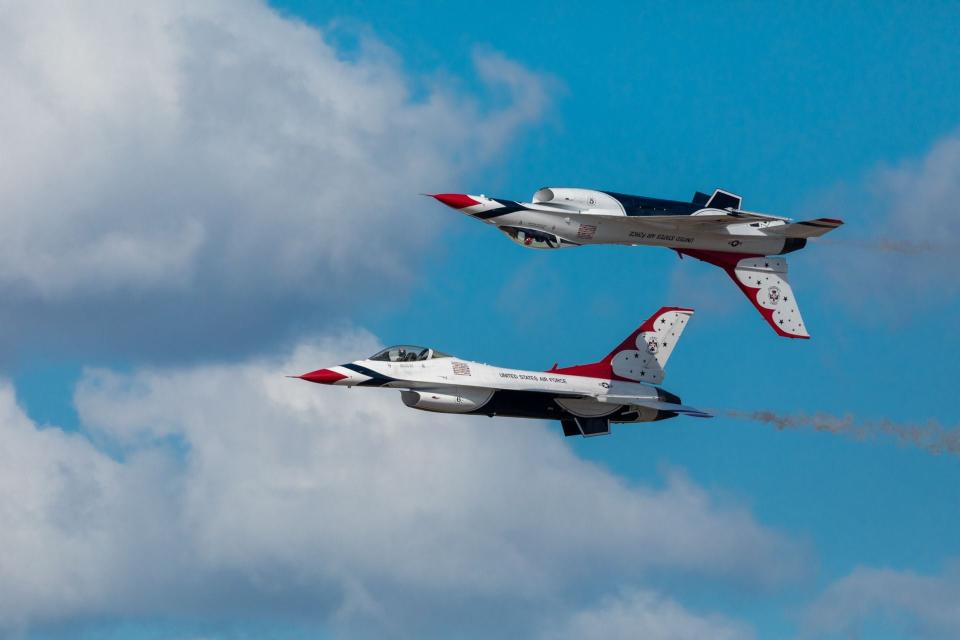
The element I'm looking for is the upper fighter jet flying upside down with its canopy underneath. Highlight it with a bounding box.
[433,187,843,338]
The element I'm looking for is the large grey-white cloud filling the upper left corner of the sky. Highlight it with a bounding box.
[0,0,547,356]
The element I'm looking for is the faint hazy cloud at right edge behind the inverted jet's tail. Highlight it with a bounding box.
[816,132,960,321]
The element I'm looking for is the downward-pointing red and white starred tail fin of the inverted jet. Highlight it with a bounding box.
[678,249,810,338]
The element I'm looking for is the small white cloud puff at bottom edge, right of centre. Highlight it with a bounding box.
[544,590,753,640]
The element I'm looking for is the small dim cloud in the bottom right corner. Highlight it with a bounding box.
[805,562,960,640]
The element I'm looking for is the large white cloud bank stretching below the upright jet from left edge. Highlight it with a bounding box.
[0,332,808,637]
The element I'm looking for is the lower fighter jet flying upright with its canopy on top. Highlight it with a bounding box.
[294,307,710,436]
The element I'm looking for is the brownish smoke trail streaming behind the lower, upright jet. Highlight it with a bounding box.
[719,409,960,455]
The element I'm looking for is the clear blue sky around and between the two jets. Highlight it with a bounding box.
[279,2,960,616]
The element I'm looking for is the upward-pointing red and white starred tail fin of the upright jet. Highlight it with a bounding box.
[551,307,693,384]
